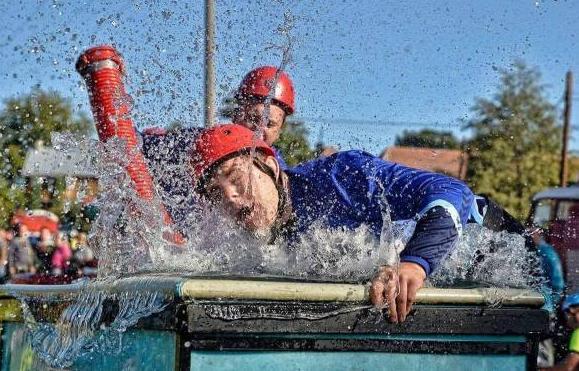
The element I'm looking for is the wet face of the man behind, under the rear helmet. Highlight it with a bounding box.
[234,103,285,146]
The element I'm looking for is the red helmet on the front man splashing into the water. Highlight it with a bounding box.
[192,124,274,181]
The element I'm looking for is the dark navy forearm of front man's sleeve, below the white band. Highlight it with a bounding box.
[400,206,458,275]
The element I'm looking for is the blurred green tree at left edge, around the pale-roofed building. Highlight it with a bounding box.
[0,89,93,227]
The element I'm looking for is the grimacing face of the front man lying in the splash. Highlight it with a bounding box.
[205,155,279,233]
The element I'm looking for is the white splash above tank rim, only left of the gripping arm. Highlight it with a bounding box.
[53,135,415,281]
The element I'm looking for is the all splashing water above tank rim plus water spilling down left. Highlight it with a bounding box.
[22,129,540,367]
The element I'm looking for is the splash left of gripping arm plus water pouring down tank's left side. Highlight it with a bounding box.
[21,134,412,367]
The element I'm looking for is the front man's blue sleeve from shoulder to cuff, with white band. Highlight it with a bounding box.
[318,151,474,274]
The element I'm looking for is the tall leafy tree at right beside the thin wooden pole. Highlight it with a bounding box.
[465,62,561,220]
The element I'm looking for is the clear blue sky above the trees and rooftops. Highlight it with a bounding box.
[0,0,579,154]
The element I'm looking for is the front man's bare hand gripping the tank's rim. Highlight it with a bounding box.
[370,262,426,323]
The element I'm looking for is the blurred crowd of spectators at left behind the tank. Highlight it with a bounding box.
[0,224,97,282]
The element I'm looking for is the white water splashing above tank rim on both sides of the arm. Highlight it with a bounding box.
[53,135,540,288]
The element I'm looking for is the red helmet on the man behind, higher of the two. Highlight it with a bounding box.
[235,66,295,115]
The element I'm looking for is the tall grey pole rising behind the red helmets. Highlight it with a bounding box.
[205,0,215,127]
